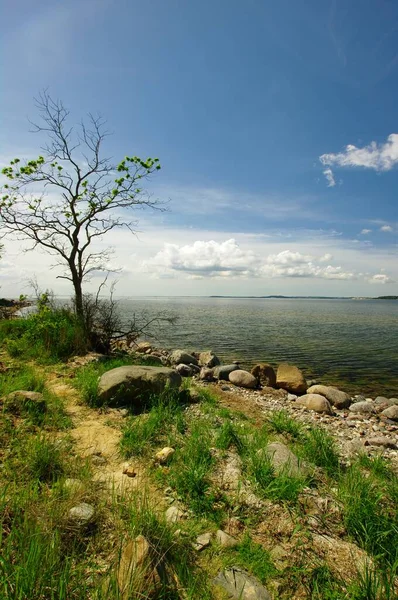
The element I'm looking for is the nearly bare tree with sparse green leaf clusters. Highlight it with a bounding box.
[0,91,161,319]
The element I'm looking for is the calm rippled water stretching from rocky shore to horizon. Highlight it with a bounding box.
[116,297,398,395]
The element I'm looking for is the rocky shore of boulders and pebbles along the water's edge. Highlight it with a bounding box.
[106,341,398,469]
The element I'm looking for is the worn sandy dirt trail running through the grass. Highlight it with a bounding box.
[47,375,145,494]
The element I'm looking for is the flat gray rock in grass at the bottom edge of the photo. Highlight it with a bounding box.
[214,567,272,600]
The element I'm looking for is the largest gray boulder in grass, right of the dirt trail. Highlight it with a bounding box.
[98,366,181,406]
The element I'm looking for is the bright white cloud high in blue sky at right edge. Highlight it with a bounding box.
[319,133,398,171]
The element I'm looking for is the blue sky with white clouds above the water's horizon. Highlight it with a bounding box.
[0,0,398,296]
